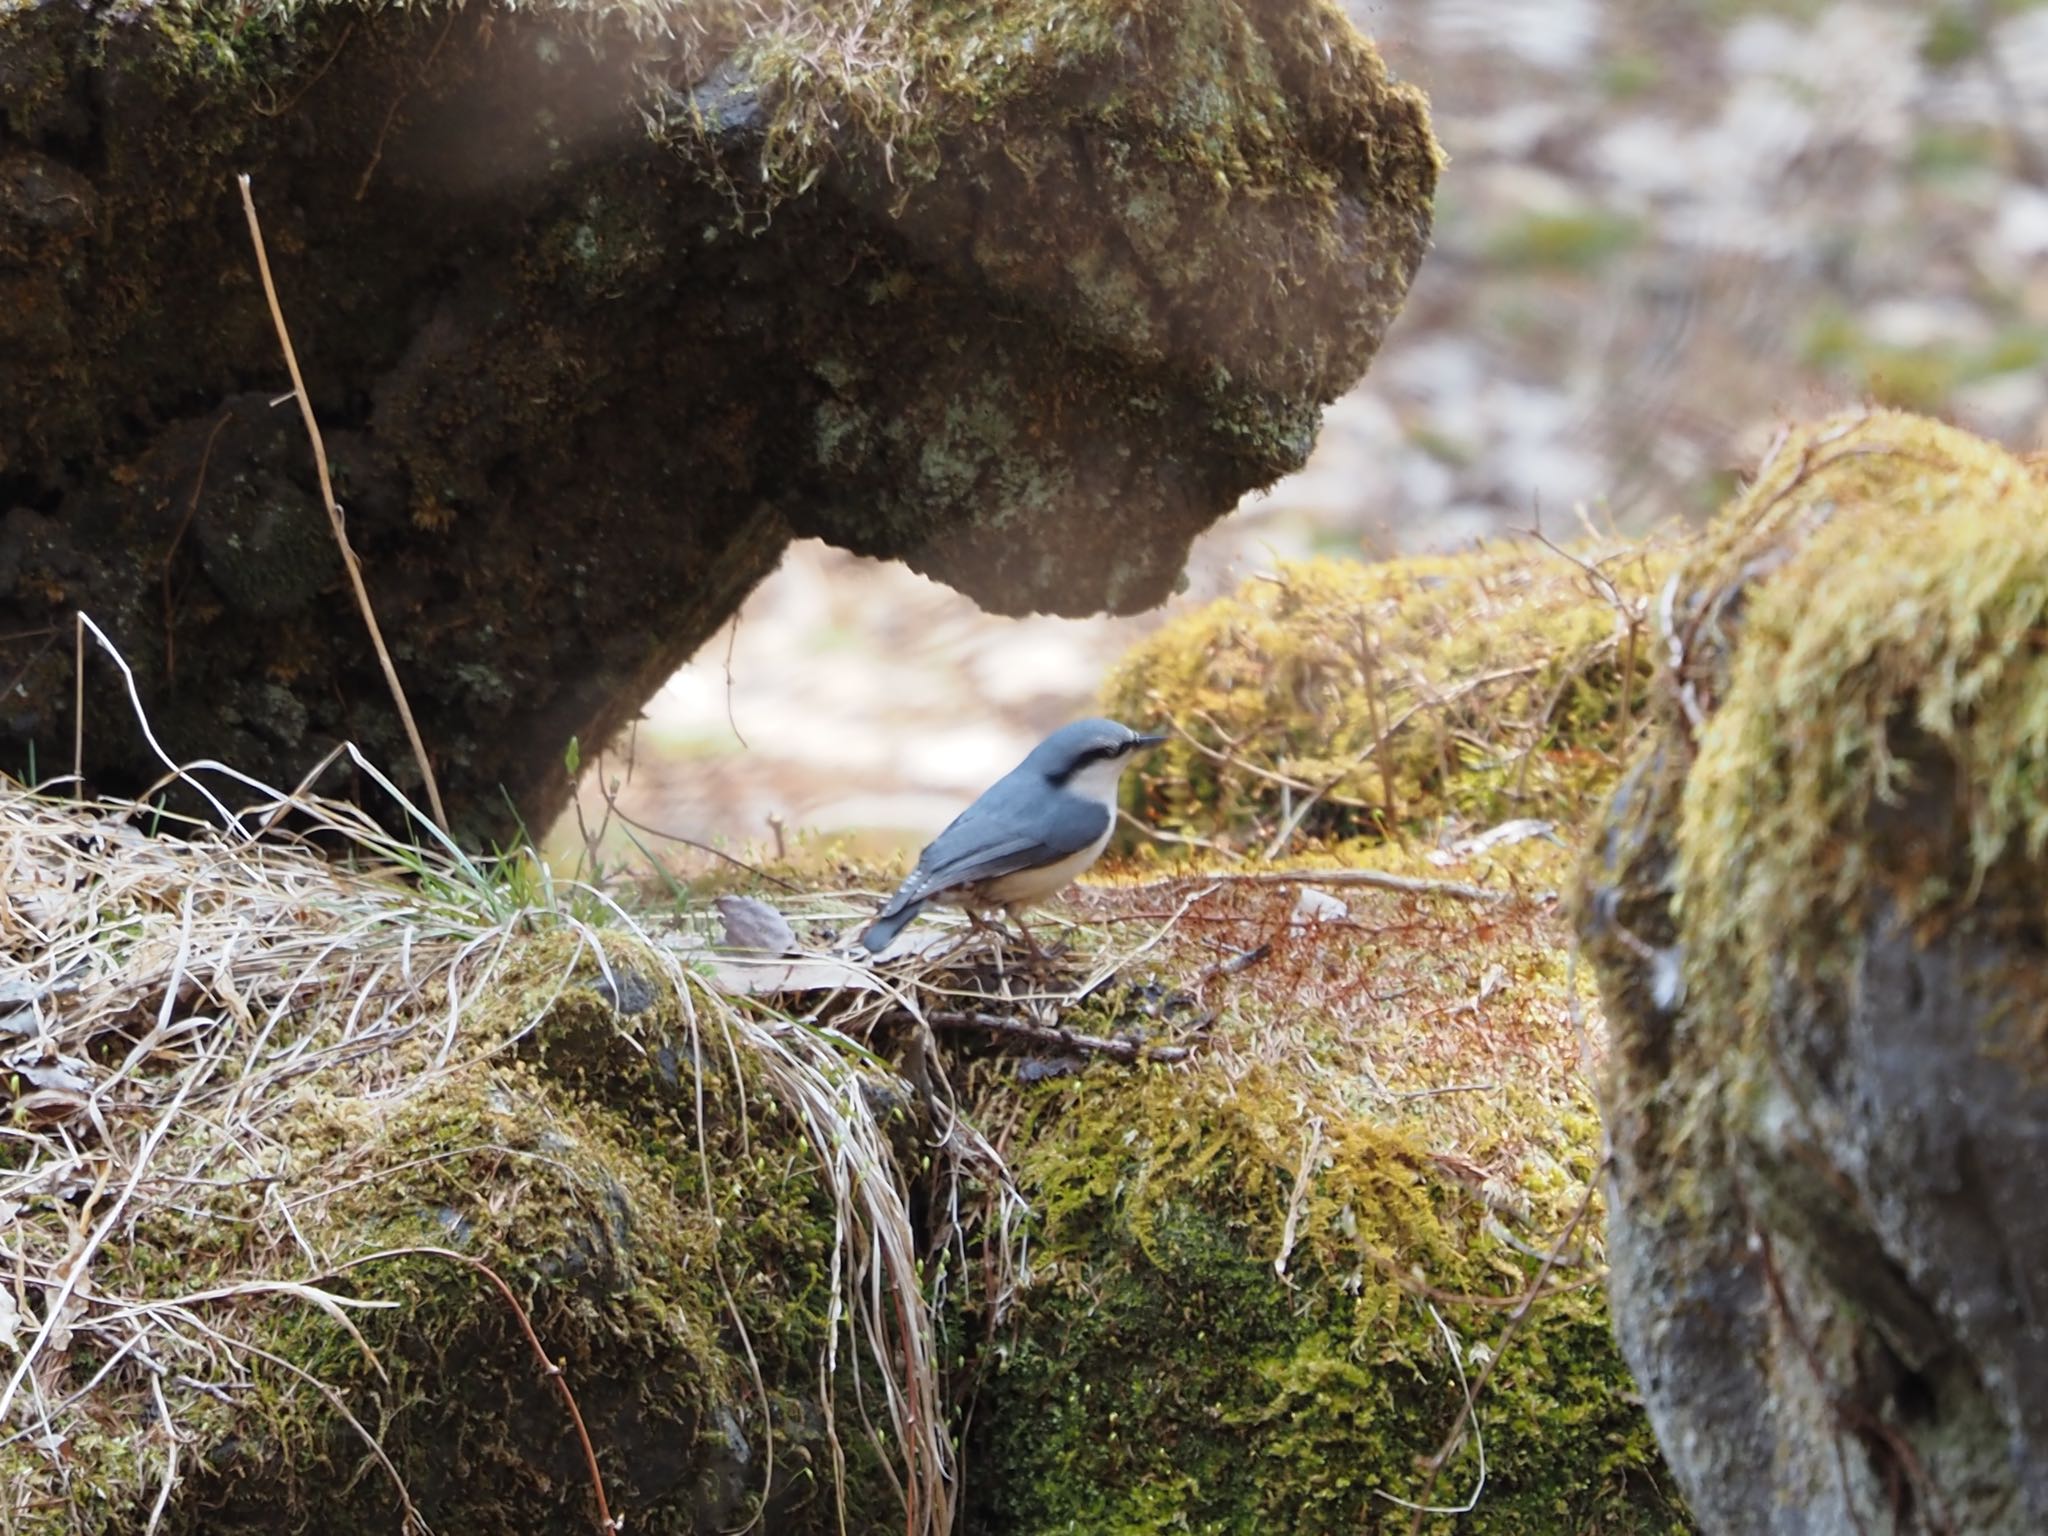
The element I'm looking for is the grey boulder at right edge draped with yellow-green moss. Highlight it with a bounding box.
[1579,412,2048,1536]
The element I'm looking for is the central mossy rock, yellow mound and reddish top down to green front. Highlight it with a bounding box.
[969,547,1690,1536]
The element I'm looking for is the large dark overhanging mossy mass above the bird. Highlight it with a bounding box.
[0,0,1436,836]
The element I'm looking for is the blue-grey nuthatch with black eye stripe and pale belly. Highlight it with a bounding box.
[860,719,1165,954]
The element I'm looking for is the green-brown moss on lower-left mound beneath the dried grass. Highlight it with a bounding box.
[0,940,901,1534]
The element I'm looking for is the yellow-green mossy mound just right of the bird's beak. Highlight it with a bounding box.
[1106,547,1667,848]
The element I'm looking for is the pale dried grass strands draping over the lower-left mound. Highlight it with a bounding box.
[0,647,1022,1532]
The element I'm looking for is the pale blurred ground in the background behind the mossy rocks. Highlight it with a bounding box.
[551,0,2048,868]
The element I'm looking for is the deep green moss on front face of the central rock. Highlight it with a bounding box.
[975,1069,1686,1534]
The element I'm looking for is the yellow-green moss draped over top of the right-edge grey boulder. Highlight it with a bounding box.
[1677,412,2048,1073]
